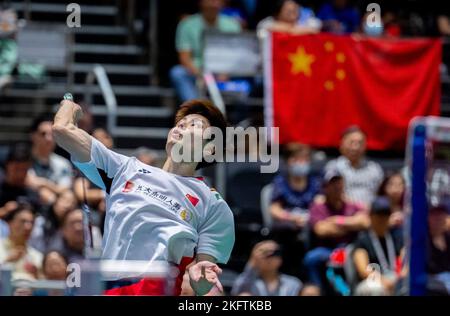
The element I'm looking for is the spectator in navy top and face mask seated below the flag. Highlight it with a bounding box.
[269,143,322,273]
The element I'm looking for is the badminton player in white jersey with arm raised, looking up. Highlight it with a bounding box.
[53,100,235,295]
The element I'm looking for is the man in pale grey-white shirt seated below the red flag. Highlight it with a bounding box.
[325,126,383,208]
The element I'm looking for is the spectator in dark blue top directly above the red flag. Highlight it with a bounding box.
[317,0,360,34]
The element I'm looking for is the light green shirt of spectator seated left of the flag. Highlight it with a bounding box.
[175,13,241,68]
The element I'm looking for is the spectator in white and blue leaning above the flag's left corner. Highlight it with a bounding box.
[257,0,321,36]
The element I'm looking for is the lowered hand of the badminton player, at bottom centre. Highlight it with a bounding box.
[189,261,223,295]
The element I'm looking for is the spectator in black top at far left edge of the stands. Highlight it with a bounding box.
[0,144,41,237]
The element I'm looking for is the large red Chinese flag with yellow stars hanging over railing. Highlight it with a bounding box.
[265,33,442,150]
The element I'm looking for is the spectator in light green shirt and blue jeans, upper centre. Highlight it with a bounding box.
[170,0,241,102]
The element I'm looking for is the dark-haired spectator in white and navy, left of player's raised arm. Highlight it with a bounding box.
[29,117,72,204]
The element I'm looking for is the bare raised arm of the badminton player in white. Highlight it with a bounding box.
[53,100,92,162]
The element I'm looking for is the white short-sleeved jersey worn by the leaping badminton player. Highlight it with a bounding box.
[72,139,235,278]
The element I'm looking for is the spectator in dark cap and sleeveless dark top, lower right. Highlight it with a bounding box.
[353,197,403,296]
